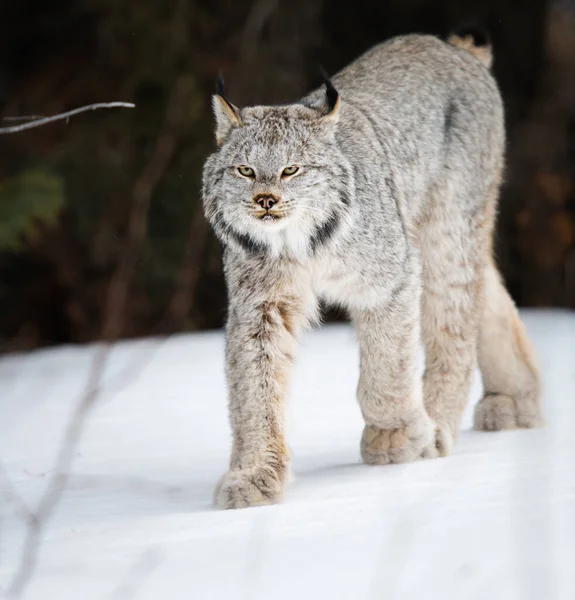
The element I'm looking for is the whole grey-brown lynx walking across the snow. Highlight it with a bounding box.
[203,30,542,508]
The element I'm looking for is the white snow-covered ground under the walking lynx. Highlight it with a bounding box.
[0,312,575,600]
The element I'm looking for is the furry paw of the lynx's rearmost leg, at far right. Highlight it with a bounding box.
[473,394,543,431]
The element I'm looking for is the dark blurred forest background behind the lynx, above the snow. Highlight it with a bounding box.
[0,0,575,350]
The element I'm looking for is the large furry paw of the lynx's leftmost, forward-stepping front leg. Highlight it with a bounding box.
[214,466,284,509]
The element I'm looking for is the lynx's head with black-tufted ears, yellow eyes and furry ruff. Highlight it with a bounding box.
[203,74,352,258]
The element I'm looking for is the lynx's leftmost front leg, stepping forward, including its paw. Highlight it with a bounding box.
[215,282,316,508]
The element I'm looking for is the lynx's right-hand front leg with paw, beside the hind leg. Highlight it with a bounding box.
[353,275,439,465]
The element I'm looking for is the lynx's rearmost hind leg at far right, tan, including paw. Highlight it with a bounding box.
[474,263,543,431]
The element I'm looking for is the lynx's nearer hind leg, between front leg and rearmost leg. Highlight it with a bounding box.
[420,181,498,446]
